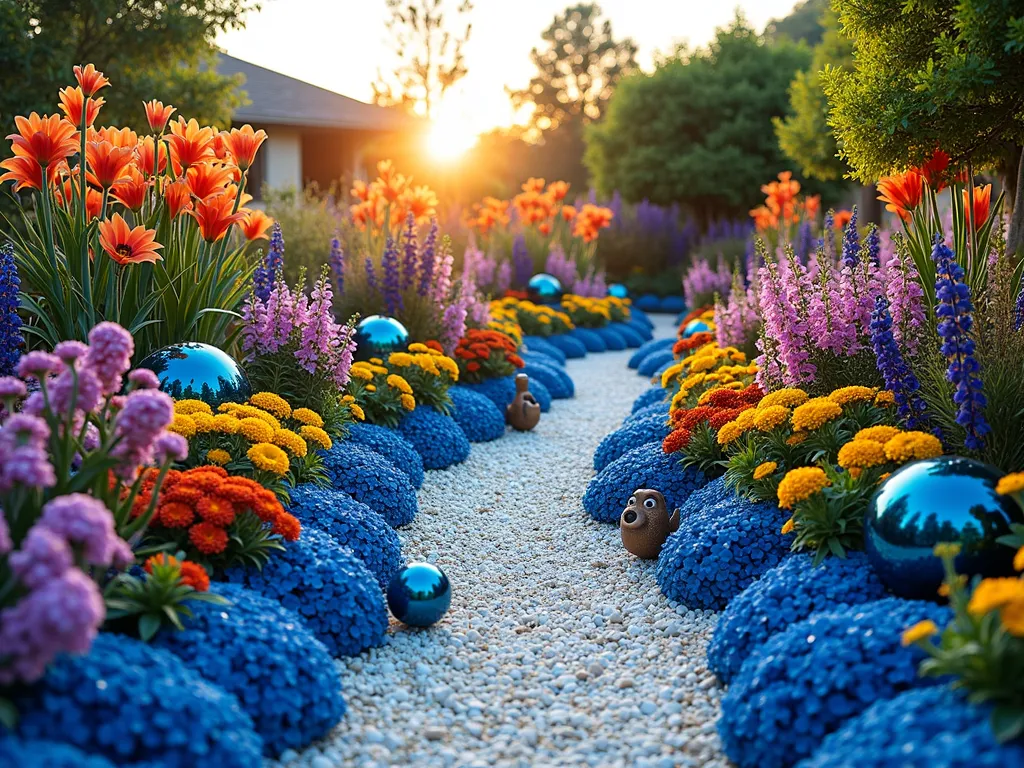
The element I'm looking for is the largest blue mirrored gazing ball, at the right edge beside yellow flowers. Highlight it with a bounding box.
[864,456,1024,600]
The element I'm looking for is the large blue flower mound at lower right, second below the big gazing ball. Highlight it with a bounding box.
[718,597,950,768]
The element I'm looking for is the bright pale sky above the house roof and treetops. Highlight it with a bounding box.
[217,0,795,144]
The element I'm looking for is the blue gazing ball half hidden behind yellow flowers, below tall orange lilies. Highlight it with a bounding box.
[138,341,253,409]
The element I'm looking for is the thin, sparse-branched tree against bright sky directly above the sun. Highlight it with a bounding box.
[373,0,473,118]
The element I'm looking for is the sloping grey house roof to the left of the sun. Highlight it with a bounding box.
[217,53,414,131]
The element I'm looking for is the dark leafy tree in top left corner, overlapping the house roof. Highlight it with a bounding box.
[0,0,259,132]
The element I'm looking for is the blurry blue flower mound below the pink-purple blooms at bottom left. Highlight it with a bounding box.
[13,632,263,768]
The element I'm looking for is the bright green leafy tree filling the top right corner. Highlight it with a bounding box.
[822,0,1024,252]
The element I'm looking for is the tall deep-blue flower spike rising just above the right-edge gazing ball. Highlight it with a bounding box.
[932,236,991,451]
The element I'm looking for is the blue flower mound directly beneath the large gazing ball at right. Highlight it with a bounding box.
[708,552,886,683]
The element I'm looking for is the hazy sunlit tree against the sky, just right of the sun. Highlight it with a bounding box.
[509,3,637,132]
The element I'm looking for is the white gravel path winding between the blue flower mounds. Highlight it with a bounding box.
[282,317,727,768]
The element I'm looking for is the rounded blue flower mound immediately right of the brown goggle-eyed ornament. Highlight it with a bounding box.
[655,496,791,610]
